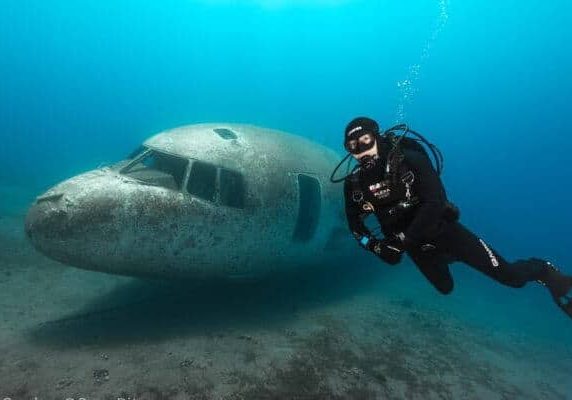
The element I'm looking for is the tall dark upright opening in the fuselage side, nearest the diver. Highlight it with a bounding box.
[293,174,322,242]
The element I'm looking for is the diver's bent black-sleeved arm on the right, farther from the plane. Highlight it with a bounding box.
[404,151,447,244]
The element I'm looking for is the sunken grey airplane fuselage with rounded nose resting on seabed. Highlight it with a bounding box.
[25,123,355,279]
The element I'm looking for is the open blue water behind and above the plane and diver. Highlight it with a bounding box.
[0,0,572,396]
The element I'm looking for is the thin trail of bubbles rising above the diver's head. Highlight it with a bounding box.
[395,0,449,123]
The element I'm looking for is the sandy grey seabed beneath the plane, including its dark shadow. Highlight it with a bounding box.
[0,215,572,400]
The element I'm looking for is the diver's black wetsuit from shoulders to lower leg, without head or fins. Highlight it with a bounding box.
[344,145,548,294]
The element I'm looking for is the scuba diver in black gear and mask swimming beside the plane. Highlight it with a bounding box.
[330,117,572,318]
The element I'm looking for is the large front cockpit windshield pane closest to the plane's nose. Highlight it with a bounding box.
[121,150,188,190]
